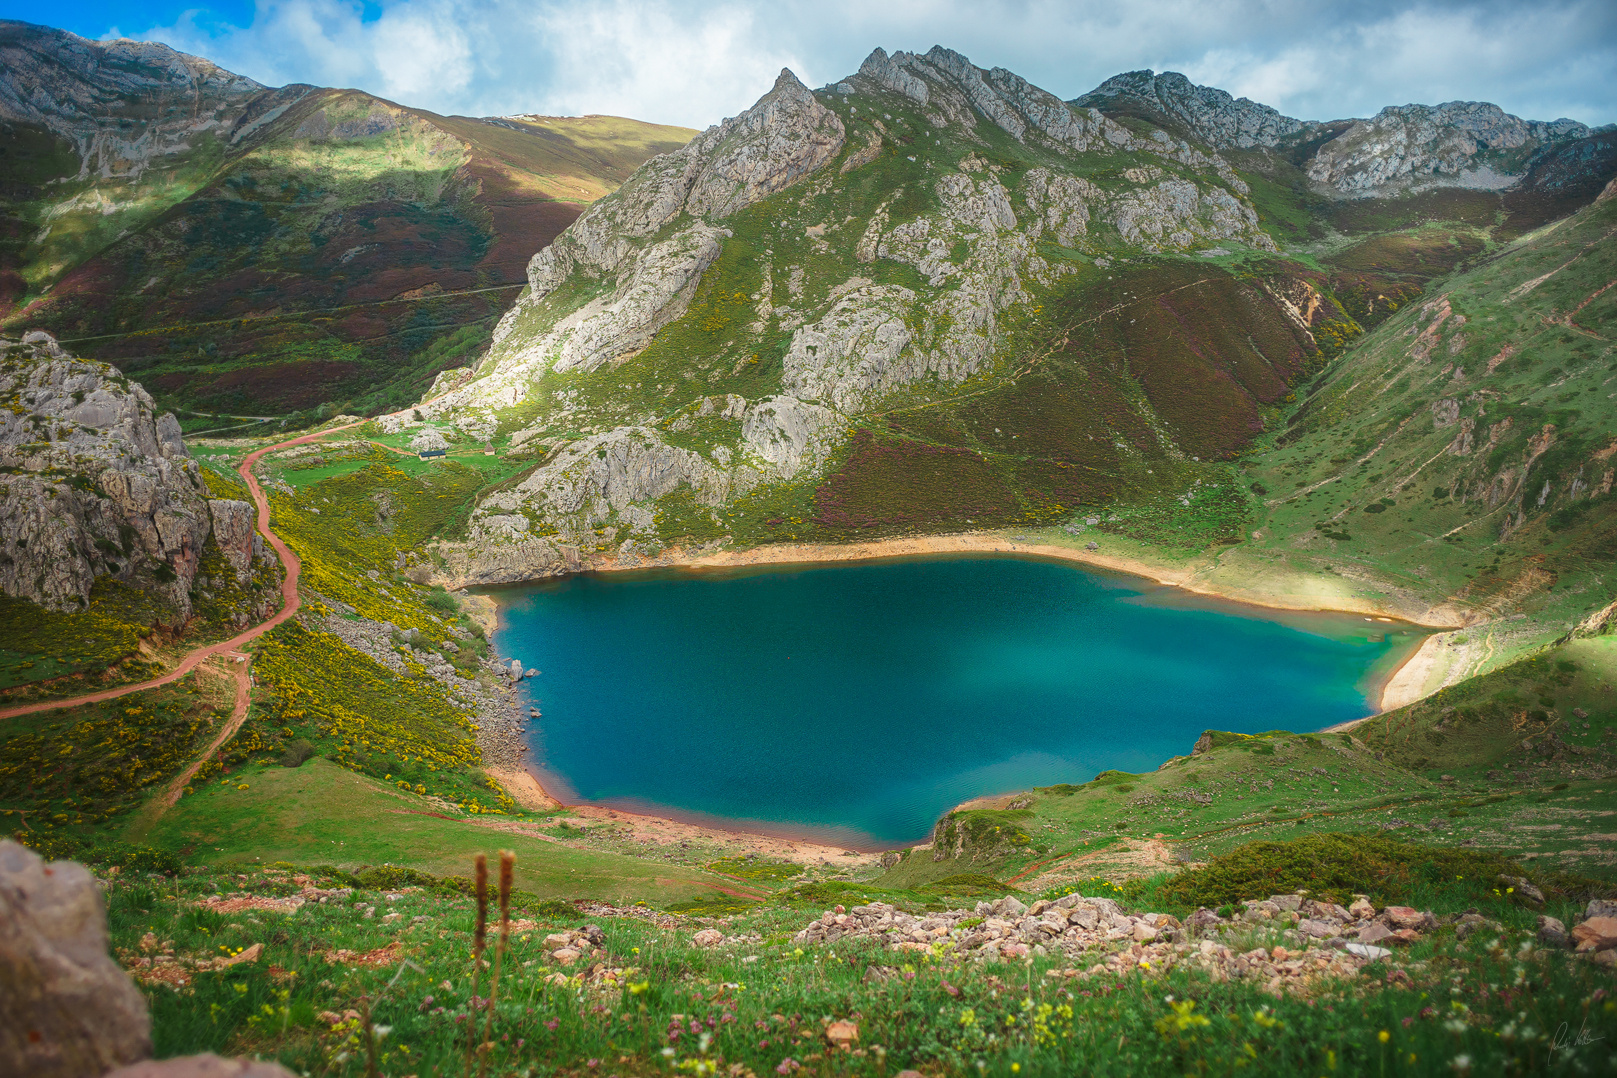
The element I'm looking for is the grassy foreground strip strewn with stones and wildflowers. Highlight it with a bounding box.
[0,844,1617,1078]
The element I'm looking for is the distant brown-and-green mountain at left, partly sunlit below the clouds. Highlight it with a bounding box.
[0,23,692,425]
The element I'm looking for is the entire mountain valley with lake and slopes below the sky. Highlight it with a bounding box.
[0,23,1617,1078]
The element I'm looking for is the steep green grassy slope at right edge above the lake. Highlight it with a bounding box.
[1221,180,1617,669]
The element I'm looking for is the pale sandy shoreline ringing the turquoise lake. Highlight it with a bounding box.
[479,532,1455,861]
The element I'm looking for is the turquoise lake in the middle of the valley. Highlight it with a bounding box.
[495,556,1420,849]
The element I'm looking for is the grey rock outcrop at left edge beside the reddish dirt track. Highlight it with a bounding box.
[0,333,215,619]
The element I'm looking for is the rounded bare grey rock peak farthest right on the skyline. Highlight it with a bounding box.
[1305,102,1590,197]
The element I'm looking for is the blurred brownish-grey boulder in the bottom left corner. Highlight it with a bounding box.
[0,840,152,1078]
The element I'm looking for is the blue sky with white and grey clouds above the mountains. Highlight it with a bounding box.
[12,0,1617,128]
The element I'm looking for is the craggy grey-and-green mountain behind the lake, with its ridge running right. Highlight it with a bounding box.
[407,48,1614,646]
